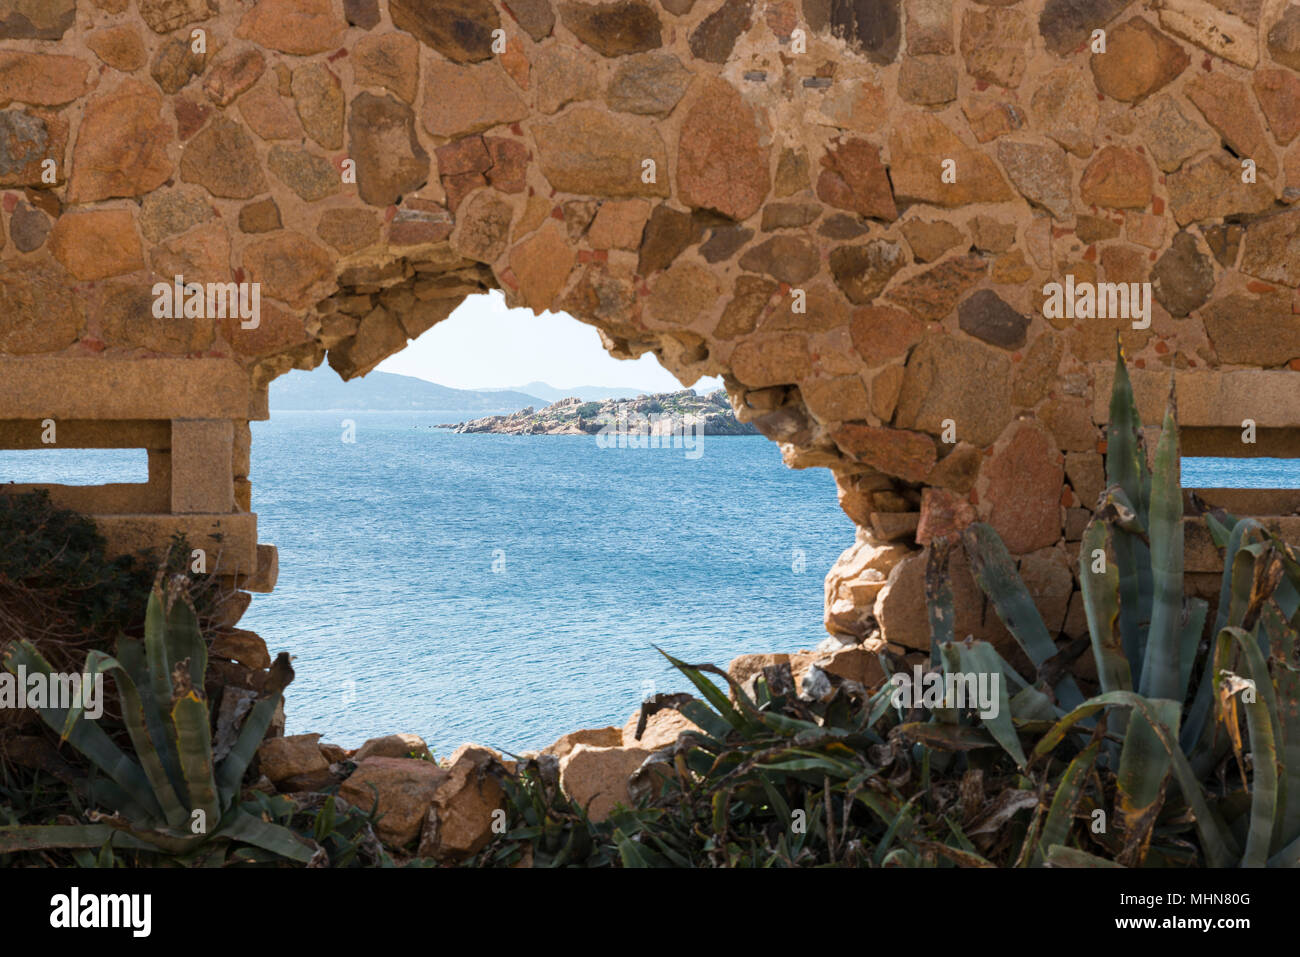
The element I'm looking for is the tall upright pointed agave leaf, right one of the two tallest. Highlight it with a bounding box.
[1139,385,1183,702]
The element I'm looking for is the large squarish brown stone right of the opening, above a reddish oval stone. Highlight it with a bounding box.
[894,334,1011,446]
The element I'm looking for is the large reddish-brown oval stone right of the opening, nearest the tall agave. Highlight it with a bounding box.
[978,420,1065,555]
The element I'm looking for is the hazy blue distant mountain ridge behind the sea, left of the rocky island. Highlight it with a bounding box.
[270,367,551,413]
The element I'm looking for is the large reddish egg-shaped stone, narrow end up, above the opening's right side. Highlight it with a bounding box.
[677,79,770,220]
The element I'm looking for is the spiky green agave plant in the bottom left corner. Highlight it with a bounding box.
[0,576,314,865]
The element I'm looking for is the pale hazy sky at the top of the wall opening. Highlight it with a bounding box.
[378,293,722,393]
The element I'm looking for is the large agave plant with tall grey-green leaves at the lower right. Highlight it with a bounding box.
[907,352,1300,866]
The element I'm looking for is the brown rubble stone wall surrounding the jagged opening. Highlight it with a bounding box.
[0,0,1300,660]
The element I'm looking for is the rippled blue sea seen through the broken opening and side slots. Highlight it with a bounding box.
[0,426,1300,754]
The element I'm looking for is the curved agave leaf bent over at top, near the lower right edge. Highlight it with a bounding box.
[1214,627,1281,867]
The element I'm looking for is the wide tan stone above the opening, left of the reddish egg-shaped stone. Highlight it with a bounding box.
[533,107,668,196]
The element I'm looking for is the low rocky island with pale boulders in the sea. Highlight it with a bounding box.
[438,389,758,436]
